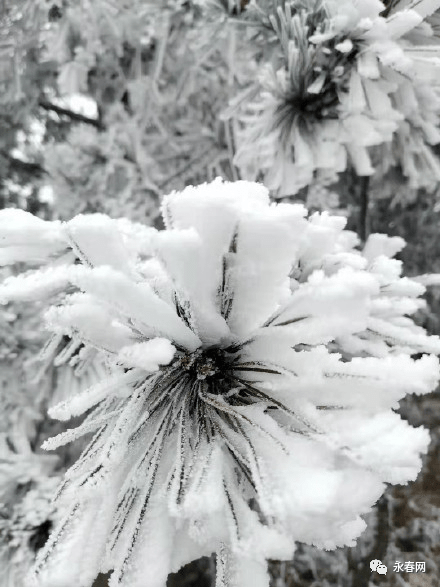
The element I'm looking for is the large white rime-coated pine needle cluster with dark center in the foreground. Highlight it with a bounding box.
[0,180,439,587]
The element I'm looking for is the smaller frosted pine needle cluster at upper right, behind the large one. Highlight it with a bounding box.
[229,0,440,195]
